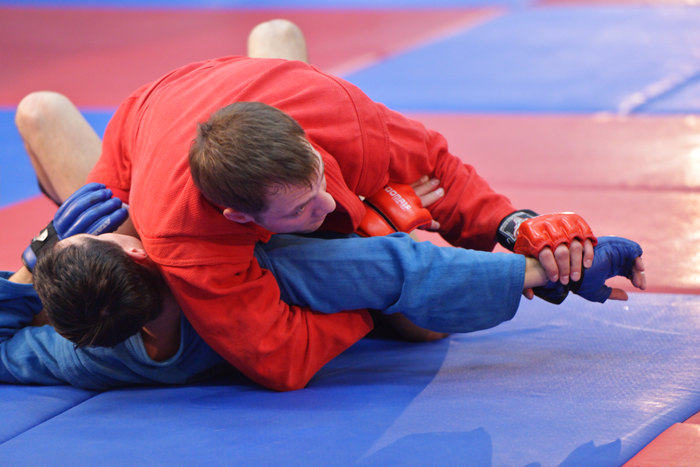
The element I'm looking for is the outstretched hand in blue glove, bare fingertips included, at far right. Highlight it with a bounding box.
[571,237,647,303]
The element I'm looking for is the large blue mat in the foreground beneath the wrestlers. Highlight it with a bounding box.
[0,294,700,467]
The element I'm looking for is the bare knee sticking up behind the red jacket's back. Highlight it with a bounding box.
[248,19,309,63]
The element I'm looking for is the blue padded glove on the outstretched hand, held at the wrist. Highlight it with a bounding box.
[533,237,642,305]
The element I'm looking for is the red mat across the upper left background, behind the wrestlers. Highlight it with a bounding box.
[0,7,501,107]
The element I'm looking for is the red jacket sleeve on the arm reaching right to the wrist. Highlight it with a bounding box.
[293,69,516,251]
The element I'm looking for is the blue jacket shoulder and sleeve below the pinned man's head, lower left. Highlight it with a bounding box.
[0,273,223,390]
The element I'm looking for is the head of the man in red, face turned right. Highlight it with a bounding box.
[189,102,335,233]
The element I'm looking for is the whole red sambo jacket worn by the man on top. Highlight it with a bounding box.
[89,57,515,390]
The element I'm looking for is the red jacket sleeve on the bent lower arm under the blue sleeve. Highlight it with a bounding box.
[148,239,373,391]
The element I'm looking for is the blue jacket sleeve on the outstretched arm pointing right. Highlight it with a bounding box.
[256,234,525,332]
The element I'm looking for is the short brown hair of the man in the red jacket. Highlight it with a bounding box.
[189,102,319,215]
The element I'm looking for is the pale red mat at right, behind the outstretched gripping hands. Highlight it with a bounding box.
[415,115,700,293]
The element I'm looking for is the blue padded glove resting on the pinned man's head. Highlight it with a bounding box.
[22,183,129,271]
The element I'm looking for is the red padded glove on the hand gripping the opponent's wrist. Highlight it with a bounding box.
[513,212,598,258]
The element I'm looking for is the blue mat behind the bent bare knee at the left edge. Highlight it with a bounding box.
[0,108,114,207]
